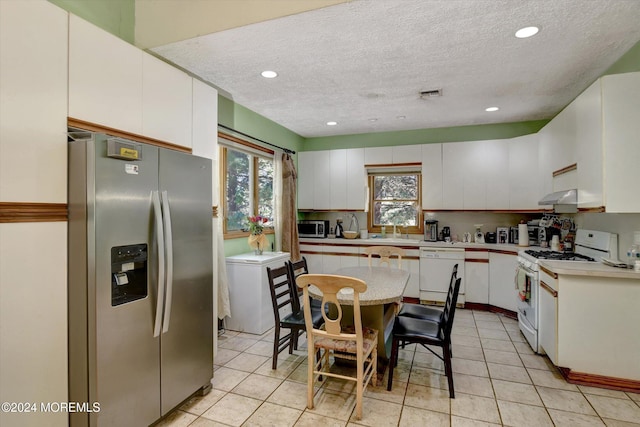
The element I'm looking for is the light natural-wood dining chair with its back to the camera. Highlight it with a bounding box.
[296,274,378,419]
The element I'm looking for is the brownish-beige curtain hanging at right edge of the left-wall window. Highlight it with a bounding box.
[282,153,301,261]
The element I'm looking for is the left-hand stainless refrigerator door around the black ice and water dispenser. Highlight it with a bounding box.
[93,141,161,425]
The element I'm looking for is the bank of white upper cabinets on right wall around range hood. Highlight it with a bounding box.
[538,72,640,213]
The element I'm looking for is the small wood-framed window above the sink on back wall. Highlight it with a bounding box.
[368,171,423,234]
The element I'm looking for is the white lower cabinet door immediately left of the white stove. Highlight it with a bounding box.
[489,252,518,312]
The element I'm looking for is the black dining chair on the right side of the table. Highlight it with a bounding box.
[387,278,462,399]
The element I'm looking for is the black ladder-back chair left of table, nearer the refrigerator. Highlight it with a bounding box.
[267,264,324,369]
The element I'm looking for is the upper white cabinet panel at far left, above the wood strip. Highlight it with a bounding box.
[0,1,68,203]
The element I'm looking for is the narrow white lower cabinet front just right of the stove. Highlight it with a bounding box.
[538,270,558,366]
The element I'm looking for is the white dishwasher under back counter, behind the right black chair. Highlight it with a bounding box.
[420,247,464,304]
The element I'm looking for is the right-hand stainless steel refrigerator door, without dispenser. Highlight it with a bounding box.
[159,149,213,414]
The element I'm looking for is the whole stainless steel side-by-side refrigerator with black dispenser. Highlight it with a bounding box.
[68,134,213,426]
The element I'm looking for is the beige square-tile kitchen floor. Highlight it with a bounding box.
[156,310,640,427]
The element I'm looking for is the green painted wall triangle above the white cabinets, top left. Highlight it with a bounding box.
[49,0,136,44]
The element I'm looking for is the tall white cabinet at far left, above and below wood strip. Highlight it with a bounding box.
[0,1,68,426]
